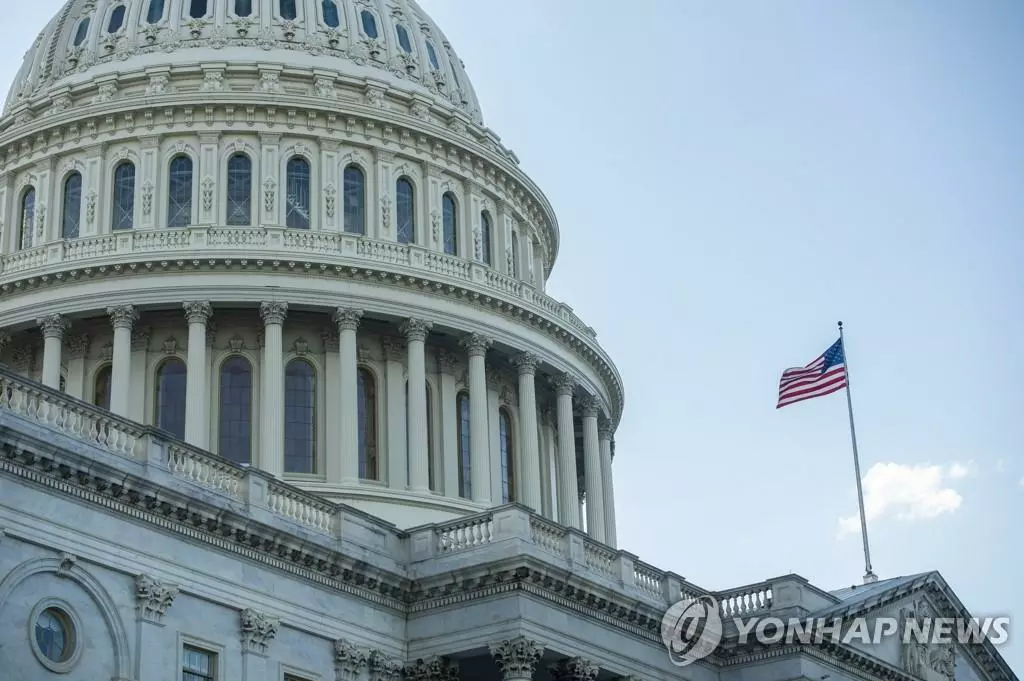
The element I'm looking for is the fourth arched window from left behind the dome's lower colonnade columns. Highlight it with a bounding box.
[285,359,316,473]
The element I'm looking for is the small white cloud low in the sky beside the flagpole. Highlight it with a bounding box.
[839,462,970,539]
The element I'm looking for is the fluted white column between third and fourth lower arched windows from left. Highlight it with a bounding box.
[259,302,288,477]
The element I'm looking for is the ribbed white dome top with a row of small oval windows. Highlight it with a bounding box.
[5,0,481,122]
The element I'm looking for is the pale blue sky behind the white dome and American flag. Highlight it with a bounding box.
[0,0,1024,672]
